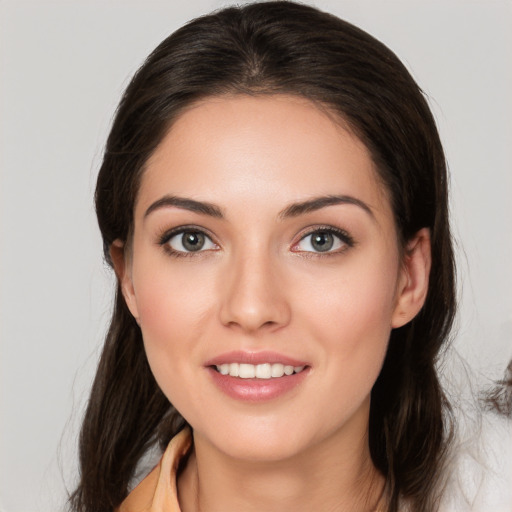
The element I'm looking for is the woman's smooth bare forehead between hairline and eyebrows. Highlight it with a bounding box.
[137,95,389,220]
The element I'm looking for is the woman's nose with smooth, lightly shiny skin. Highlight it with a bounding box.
[220,247,291,333]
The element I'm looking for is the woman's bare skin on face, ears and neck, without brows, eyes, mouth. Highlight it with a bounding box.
[111,96,430,512]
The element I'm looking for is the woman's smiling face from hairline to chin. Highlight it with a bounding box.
[117,95,428,460]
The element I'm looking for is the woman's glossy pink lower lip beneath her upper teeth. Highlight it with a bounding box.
[208,368,309,402]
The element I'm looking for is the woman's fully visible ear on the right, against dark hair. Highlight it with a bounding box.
[391,228,432,328]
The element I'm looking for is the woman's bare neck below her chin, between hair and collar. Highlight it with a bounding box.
[178,412,384,512]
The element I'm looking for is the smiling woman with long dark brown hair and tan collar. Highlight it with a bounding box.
[72,2,455,512]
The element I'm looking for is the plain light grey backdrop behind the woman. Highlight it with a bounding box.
[0,0,512,512]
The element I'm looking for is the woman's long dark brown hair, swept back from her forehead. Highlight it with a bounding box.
[70,1,455,512]
